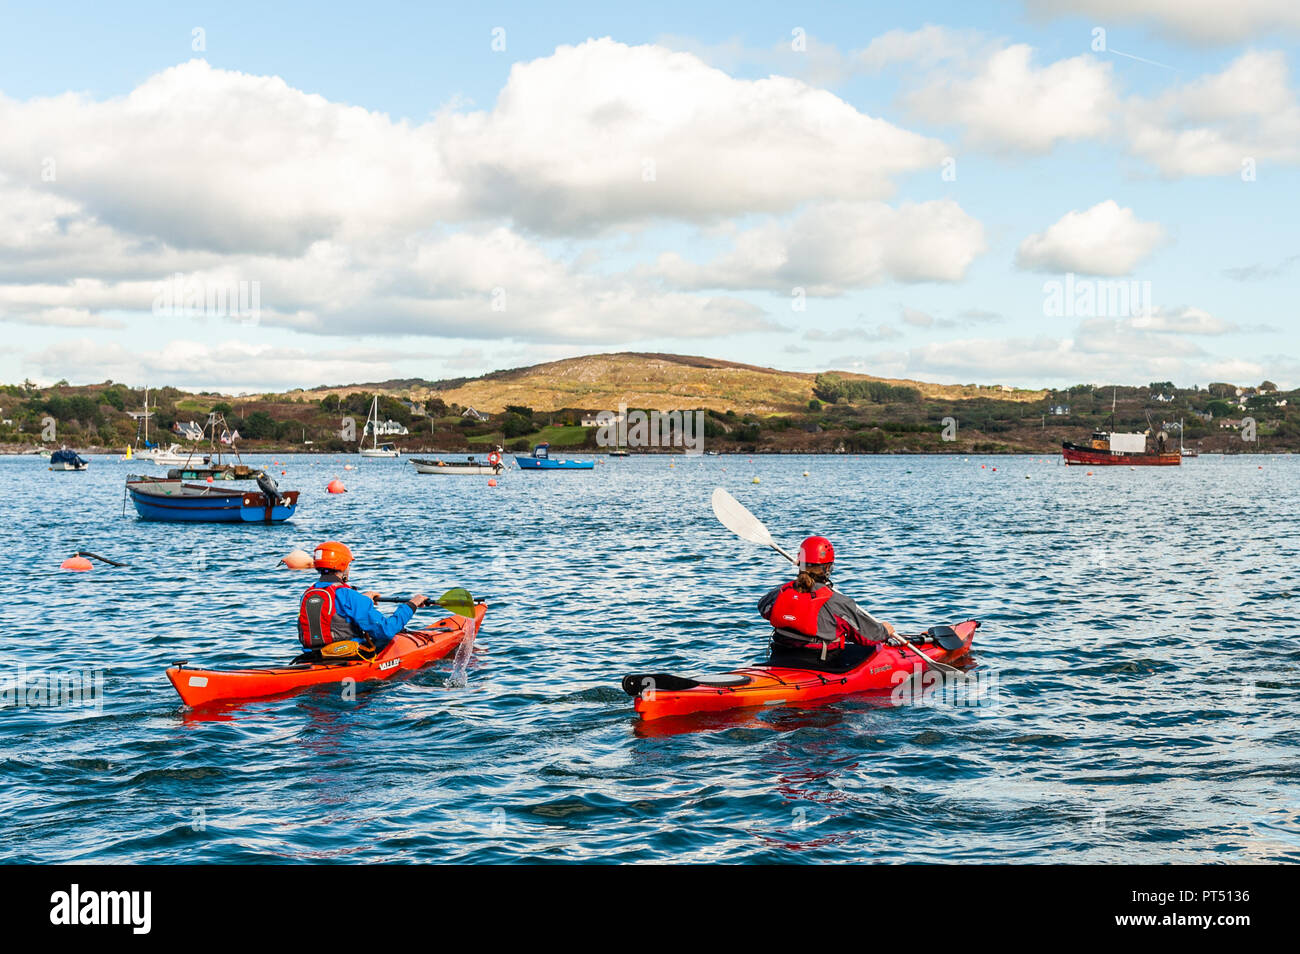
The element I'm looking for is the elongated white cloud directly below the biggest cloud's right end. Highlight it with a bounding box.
[654,199,985,295]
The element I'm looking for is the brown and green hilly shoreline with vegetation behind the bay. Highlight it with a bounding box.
[0,354,1300,454]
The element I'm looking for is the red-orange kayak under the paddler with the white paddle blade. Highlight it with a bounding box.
[623,620,979,719]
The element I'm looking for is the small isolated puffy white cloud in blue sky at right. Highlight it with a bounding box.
[1015,199,1165,276]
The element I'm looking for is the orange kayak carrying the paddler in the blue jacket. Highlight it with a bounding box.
[166,603,488,707]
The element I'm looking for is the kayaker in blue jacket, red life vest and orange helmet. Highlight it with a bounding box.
[298,541,429,650]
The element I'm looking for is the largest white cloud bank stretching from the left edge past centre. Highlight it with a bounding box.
[0,39,945,255]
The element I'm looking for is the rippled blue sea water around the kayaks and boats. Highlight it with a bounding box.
[0,455,1300,863]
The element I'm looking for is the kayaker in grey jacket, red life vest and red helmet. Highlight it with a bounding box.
[758,537,894,672]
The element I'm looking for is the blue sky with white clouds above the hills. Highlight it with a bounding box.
[0,0,1300,393]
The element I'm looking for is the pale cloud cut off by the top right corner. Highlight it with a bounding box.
[1026,0,1300,45]
